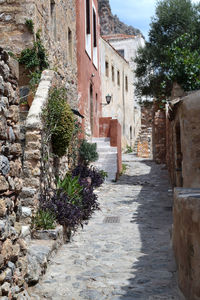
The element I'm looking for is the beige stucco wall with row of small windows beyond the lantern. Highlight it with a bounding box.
[100,38,135,149]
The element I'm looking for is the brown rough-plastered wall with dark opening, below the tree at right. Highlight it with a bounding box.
[167,91,200,188]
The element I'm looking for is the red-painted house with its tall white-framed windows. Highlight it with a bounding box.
[76,0,102,137]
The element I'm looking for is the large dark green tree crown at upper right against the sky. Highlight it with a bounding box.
[135,0,200,100]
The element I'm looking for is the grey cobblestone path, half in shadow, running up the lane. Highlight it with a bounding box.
[30,154,180,300]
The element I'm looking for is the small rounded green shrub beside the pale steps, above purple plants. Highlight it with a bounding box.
[79,139,99,165]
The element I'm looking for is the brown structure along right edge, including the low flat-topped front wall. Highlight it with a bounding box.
[166,87,200,300]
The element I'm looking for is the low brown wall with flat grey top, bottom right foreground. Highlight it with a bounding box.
[173,188,200,300]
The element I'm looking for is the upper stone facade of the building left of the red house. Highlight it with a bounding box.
[0,0,78,108]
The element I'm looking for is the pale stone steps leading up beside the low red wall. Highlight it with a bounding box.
[92,138,117,181]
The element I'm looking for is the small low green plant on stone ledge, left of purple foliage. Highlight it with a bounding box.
[33,209,56,230]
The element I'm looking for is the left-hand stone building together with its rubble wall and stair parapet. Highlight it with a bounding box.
[0,0,78,299]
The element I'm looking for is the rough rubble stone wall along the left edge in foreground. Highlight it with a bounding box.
[0,48,27,299]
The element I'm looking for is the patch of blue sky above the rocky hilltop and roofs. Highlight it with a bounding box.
[110,0,200,38]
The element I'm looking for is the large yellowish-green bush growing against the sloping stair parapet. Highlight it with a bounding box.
[44,88,74,157]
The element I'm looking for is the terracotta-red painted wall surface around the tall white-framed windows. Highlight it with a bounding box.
[76,0,102,137]
